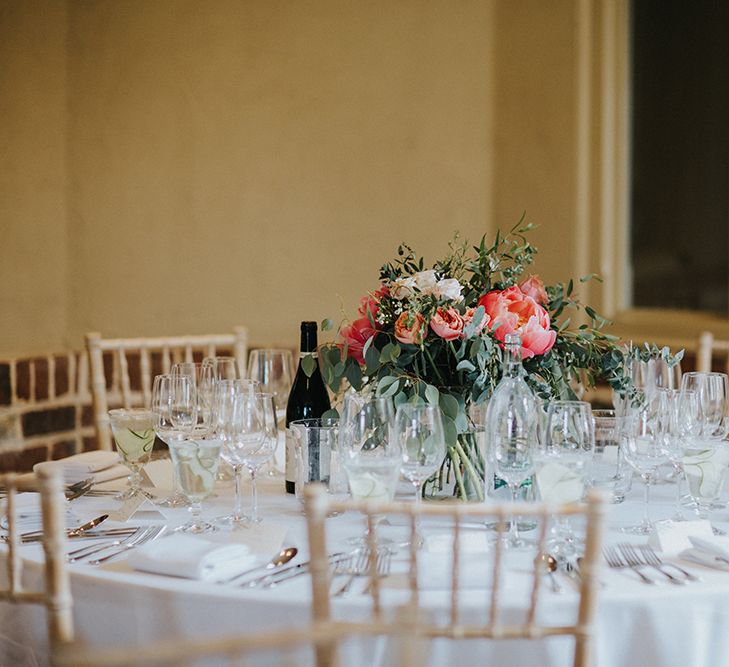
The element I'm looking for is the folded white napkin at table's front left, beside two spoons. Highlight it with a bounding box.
[129,533,258,581]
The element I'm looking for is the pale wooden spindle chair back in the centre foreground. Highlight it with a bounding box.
[305,485,605,667]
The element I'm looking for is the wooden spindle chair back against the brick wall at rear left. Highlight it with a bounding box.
[86,327,248,450]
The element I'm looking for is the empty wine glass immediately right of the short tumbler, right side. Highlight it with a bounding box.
[620,392,670,535]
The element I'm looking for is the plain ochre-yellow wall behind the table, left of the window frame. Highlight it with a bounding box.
[0,0,598,356]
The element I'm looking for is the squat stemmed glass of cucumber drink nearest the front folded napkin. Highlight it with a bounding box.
[169,432,223,533]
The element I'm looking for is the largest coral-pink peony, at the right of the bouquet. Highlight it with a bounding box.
[478,287,557,359]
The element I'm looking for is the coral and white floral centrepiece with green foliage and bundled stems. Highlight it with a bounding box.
[320,225,660,498]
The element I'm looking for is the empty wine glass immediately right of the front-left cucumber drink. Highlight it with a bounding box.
[216,388,267,530]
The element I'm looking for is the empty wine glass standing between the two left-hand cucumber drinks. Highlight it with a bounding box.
[152,373,198,507]
